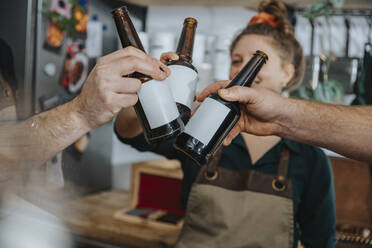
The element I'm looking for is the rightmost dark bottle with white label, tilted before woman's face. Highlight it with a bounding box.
[174,51,268,165]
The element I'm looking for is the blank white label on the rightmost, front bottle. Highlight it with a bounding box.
[184,97,230,145]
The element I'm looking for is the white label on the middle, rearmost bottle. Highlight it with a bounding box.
[167,65,198,109]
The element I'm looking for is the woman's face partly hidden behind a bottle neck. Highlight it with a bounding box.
[230,34,294,94]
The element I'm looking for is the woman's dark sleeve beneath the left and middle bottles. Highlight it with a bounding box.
[114,127,179,159]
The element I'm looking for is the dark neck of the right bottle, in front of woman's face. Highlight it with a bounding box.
[226,54,267,88]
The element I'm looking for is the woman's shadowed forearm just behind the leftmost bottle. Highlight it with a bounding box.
[115,107,142,138]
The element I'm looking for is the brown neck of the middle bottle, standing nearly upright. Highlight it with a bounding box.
[176,22,196,63]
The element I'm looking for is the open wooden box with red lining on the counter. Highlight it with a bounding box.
[114,159,185,230]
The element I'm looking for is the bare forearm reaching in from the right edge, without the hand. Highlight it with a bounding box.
[278,99,372,162]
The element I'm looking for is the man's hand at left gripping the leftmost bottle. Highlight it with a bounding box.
[74,47,170,129]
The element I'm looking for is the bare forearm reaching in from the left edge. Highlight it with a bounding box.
[0,100,90,177]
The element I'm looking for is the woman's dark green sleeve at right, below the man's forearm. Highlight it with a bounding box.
[298,148,337,248]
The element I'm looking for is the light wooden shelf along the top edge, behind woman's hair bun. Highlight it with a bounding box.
[123,0,372,9]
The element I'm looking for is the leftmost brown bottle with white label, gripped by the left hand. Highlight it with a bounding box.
[112,6,184,144]
